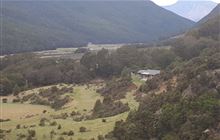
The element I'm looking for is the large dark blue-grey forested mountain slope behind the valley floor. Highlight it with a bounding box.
[1,1,194,53]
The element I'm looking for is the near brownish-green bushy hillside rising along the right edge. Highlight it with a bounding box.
[108,9,220,140]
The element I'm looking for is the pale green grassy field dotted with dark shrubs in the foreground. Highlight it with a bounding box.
[1,80,138,140]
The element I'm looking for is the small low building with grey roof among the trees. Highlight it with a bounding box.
[137,69,160,81]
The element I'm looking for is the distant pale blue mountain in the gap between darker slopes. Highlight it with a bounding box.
[164,0,217,21]
